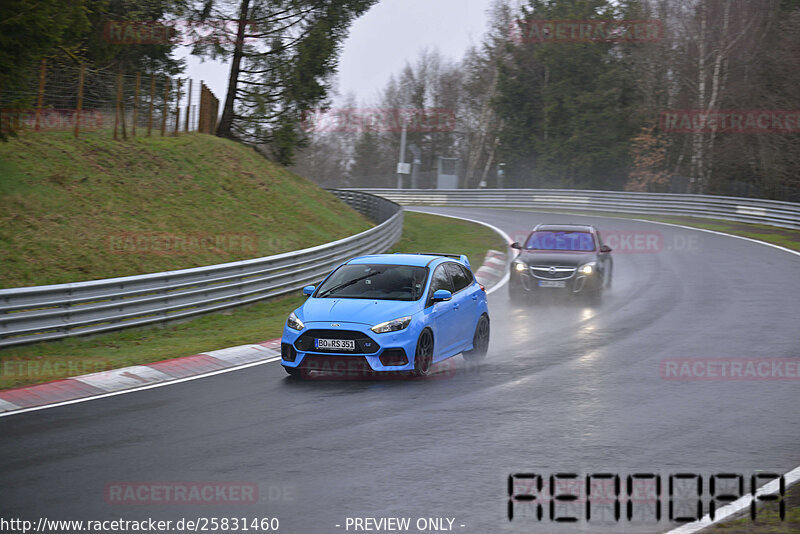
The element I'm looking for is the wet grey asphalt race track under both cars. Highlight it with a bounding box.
[0,208,800,534]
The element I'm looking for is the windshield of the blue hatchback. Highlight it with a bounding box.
[315,264,428,301]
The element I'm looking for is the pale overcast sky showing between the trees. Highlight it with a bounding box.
[181,0,504,105]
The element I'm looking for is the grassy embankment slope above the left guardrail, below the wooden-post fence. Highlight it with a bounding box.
[0,132,372,287]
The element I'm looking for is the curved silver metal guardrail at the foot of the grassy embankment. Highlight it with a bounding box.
[0,191,403,347]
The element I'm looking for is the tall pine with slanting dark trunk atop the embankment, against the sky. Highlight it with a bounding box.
[195,0,376,165]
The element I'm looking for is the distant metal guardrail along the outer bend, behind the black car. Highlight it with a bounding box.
[358,189,800,230]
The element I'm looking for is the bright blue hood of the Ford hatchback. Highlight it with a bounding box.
[300,297,422,326]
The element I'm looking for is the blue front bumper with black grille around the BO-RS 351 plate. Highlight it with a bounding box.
[281,322,418,378]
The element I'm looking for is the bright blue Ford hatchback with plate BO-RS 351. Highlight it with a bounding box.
[281,254,489,376]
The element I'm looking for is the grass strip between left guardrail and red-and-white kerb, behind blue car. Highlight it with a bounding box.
[0,213,505,389]
